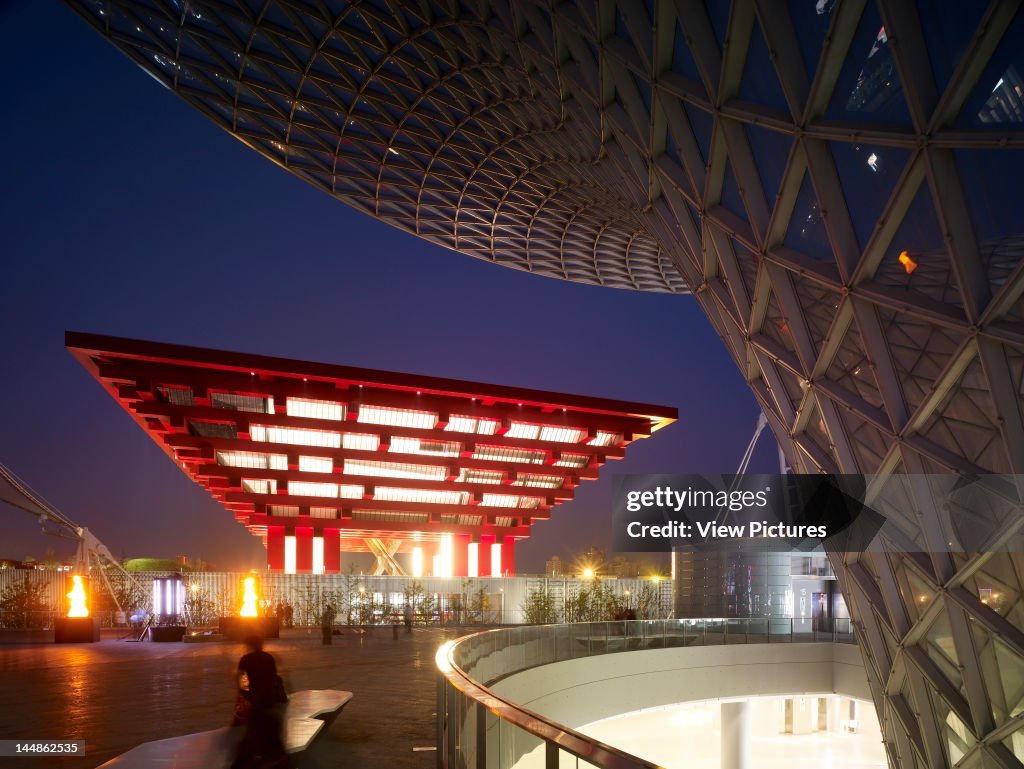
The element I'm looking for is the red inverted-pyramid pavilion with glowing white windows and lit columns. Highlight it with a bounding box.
[66,332,678,576]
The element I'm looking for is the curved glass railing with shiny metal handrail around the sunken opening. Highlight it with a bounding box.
[436,618,854,769]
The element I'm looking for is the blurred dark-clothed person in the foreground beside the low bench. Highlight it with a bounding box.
[231,636,288,769]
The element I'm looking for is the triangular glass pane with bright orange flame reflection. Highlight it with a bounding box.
[872,182,964,310]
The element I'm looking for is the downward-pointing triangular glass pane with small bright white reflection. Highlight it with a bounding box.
[829,141,910,250]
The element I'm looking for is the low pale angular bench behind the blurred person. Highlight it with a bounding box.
[98,689,352,769]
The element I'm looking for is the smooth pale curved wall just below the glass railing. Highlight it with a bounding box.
[490,643,871,728]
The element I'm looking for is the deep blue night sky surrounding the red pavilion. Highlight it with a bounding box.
[0,3,777,571]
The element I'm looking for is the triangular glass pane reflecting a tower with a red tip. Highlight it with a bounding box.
[825,3,910,125]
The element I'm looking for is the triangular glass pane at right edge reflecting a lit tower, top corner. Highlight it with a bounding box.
[956,9,1024,127]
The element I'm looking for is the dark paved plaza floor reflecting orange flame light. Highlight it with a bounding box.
[0,627,460,769]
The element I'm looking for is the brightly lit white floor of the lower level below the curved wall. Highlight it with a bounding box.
[579,697,888,769]
